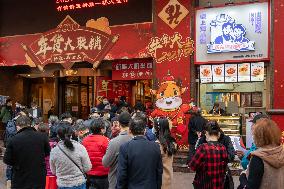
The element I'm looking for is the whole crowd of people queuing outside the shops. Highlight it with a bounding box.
[0,98,284,189]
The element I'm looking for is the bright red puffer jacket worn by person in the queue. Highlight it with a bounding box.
[82,135,109,176]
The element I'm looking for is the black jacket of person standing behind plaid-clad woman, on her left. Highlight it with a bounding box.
[188,115,206,145]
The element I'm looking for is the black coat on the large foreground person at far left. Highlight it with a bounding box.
[4,127,50,189]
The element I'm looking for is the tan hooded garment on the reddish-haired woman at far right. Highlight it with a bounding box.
[252,146,284,189]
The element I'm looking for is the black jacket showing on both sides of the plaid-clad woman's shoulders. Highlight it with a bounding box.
[198,133,235,162]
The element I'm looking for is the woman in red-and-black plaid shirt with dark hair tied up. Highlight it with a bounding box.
[189,121,228,189]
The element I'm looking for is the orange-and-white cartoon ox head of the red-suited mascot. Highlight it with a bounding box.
[151,73,186,111]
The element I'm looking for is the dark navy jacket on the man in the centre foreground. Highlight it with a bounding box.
[116,136,163,189]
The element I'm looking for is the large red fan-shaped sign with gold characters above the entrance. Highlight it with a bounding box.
[23,16,118,69]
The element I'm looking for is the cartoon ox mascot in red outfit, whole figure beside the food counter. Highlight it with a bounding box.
[151,73,192,148]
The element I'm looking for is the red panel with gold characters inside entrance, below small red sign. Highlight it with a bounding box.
[96,77,131,101]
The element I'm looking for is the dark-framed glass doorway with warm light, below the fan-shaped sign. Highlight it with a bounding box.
[60,77,94,119]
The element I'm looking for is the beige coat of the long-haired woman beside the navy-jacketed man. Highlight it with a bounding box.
[156,141,173,189]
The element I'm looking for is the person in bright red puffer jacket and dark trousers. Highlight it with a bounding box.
[82,118,109,189]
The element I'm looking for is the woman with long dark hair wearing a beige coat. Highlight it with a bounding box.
[153,118,176,189]
